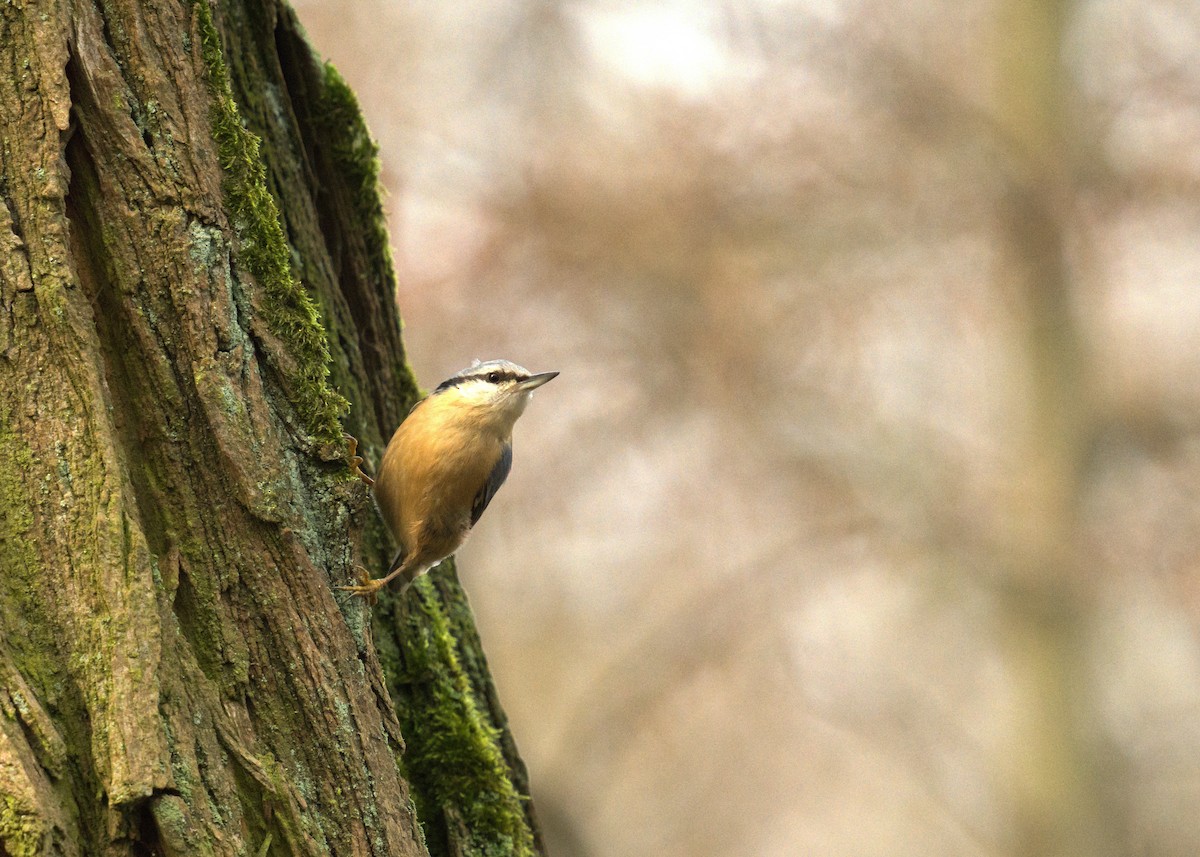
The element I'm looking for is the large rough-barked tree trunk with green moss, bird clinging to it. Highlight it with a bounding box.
[0,0,541,856]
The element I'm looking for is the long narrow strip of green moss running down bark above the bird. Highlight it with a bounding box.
[196,0,349,443]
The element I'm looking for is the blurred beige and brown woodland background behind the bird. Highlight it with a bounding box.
[296,0,1200,857]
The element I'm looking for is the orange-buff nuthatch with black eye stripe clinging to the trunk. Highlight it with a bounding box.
[338,360,558,604]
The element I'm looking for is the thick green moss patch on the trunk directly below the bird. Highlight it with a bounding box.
[377,566,535,857]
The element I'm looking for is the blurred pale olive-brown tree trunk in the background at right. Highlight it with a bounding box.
[996,0,1120,857]
